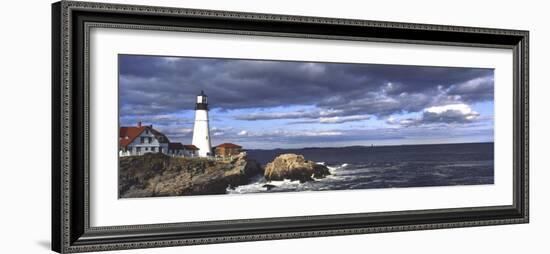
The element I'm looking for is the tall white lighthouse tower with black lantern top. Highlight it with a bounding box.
[193,91,213,157]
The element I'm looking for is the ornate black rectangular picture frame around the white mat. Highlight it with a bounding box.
[51,1,529,253]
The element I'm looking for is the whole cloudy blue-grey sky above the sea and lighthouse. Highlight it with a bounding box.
[119,55,494,149]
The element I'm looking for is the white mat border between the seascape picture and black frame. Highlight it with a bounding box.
[90,28,513,227]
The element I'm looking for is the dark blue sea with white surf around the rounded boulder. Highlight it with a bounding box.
[228,143,494,193]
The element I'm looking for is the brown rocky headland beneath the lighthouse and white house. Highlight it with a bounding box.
[118,153,262,198]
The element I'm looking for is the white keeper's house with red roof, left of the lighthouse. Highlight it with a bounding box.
[118,122,198,157]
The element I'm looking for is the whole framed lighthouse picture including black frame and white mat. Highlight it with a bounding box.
[52,1,529,253]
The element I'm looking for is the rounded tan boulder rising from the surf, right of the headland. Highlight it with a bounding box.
[264,153,330,182]
